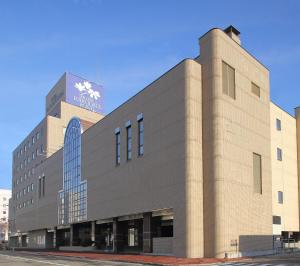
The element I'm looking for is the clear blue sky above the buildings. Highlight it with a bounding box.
[0,0,300,188]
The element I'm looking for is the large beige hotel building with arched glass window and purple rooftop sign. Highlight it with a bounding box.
[10,26,300,258]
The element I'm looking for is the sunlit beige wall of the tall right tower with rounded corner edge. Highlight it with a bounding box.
[198,29,272,257]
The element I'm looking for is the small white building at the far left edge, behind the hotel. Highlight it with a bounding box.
[0,189,11,242]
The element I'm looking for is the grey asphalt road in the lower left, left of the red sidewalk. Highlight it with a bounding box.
[0,251,142,266]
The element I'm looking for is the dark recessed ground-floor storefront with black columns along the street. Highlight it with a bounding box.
[10,209,174,255]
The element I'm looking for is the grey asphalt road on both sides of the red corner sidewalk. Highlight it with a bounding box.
[0,251,300,266]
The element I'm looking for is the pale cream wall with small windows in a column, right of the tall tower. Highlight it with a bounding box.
[270,103,299,235]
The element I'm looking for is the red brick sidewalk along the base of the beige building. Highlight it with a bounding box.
[43,251,245,265]
